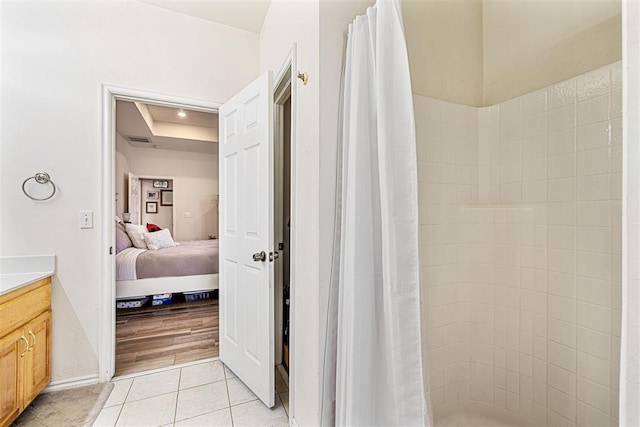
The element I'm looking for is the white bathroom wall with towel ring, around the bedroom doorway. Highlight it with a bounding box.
[0,1,259,381]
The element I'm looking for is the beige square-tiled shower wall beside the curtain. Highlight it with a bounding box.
[414,63,622,426]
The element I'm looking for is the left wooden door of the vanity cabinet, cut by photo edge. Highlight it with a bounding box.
[0,329,28,426]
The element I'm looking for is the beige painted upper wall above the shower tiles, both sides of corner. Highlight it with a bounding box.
[402,0,622,106]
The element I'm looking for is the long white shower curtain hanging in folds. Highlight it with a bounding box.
[322,0,432,426]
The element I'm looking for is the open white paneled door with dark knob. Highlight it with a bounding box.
[218,72,275,407]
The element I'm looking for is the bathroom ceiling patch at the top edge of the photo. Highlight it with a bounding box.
[138,0,271,33]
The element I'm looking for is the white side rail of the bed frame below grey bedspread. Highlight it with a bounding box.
[116,274,218,299]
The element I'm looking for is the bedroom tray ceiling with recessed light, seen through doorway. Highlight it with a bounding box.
[116,100,218,154]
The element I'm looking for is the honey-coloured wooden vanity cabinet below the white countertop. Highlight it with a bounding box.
[0,278,51,427]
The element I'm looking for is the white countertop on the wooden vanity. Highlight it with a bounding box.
[0,255,56,295]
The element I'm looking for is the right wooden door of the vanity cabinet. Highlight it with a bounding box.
[24,310,51,402]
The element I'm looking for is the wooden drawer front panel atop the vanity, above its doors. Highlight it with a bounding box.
[0,279,51,337]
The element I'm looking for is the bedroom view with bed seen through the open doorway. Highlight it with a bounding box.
[114,99,219,376]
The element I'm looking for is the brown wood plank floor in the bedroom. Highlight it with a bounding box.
[115,299,219,376]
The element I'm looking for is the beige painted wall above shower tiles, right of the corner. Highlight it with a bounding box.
[482,0,622,105]
